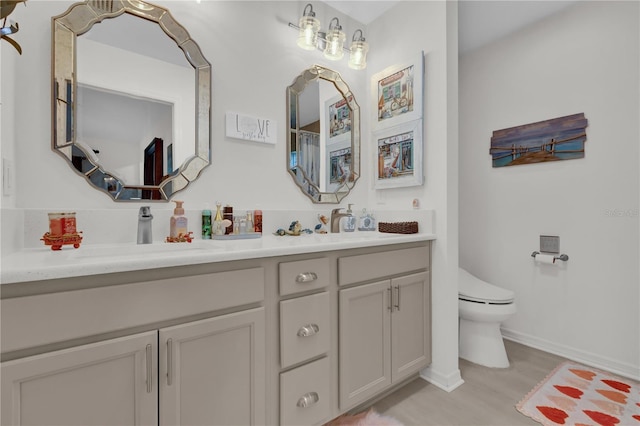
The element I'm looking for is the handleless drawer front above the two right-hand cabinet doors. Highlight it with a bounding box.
[338,245,430,285]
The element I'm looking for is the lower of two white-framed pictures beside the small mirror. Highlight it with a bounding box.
[374,120,423,189]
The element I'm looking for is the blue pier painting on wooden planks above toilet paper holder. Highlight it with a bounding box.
[490,113,588,167]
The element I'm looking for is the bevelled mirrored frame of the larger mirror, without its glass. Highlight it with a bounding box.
[51,0,211,201]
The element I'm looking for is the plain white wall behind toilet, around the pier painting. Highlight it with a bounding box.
[460,1,640,378]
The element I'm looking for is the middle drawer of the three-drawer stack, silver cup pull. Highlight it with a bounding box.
[280,292,331,368]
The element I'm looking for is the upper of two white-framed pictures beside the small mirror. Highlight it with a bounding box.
[371,51,424,131]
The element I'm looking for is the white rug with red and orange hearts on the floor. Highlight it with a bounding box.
[516,361,640,426]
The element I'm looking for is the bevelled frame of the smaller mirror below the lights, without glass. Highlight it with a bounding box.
[286,65,360,204]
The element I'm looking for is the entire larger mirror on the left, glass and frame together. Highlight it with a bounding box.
[53,0,211,201]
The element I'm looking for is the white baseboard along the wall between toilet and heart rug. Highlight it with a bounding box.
[501,328,640,381]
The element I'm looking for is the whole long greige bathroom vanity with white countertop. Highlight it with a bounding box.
[1,232,434,425]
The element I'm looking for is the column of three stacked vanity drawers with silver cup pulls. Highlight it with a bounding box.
[278,257,336,426]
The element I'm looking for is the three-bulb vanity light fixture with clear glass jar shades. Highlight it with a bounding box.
[289,3,369,70]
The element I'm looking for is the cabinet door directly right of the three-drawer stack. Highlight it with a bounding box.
[339,280,391,410]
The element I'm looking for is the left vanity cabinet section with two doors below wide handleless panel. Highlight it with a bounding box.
[1,267,267,426]
